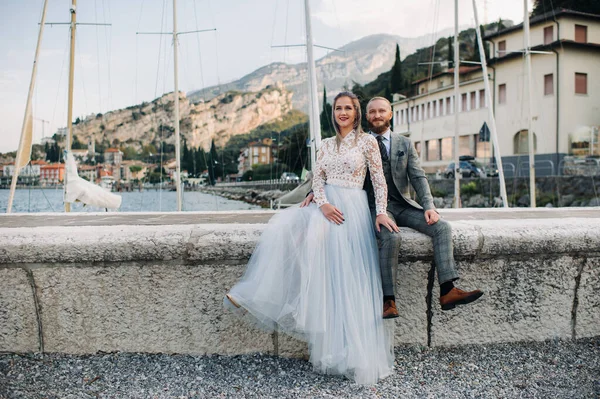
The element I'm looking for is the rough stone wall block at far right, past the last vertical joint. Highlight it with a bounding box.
[575,258,600,338]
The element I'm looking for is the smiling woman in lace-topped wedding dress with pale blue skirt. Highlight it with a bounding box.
[224,92,397,384]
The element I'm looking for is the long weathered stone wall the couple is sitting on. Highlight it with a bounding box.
[0,213,600,356]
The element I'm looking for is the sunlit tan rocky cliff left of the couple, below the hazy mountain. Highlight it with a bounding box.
[74,85,292,150]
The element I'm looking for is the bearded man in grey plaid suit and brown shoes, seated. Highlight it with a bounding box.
[302,97,483,319]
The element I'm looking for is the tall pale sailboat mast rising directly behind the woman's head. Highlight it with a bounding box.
[304,0,321,170]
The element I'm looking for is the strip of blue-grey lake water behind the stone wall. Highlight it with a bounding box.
[0,189,261,213]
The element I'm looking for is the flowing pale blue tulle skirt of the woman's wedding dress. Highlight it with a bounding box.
[225,185,394,384]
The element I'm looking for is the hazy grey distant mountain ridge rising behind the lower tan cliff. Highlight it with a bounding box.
[188,29,460,111]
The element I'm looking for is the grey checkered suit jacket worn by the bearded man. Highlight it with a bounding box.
[364,132,435,210]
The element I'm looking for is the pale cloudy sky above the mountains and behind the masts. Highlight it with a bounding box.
[0,0,531,152]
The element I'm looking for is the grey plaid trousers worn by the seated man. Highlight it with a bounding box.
[376,200,459,296]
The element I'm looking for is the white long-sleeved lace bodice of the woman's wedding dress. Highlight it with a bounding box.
[312,132,387,215]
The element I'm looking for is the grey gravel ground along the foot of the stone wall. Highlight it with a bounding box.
[0,337,600,399]
